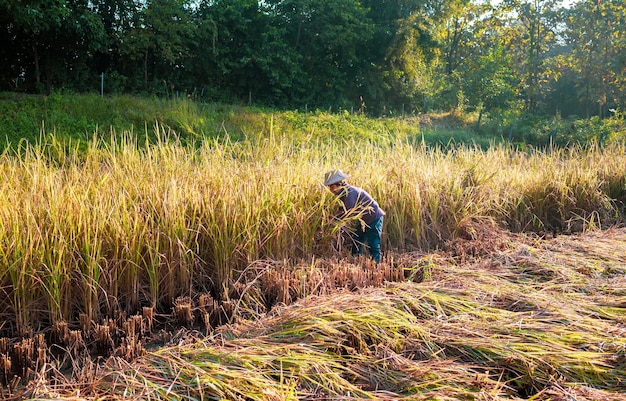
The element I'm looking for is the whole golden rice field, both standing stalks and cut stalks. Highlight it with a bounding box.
[0,122,626,400]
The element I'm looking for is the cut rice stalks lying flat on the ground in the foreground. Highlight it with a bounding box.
[6,229,626,401]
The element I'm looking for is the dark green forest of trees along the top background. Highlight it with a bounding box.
[0,0,626,119]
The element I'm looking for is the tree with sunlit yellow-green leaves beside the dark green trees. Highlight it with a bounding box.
[354,0,474,113]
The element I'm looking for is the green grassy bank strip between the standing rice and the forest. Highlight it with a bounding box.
[0,93,626,154]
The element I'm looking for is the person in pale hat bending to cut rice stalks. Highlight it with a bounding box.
[324,170,385,263]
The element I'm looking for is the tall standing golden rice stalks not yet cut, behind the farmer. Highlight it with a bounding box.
[0,122,626,335]
